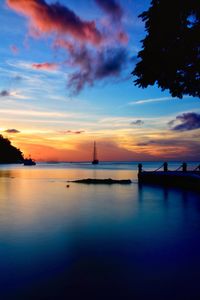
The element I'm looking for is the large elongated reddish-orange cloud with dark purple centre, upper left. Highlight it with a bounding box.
[6,0,103,45]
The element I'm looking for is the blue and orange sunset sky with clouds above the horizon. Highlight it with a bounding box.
[0,0,200,161]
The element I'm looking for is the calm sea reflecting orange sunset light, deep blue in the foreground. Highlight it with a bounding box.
[0,162,200,300]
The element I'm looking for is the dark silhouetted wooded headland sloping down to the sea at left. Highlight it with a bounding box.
[0,134,24,164]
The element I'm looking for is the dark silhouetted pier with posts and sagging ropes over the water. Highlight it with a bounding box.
[138,162,200,190]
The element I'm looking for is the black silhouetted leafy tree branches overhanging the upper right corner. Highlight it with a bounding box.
[132,0,200,98]
